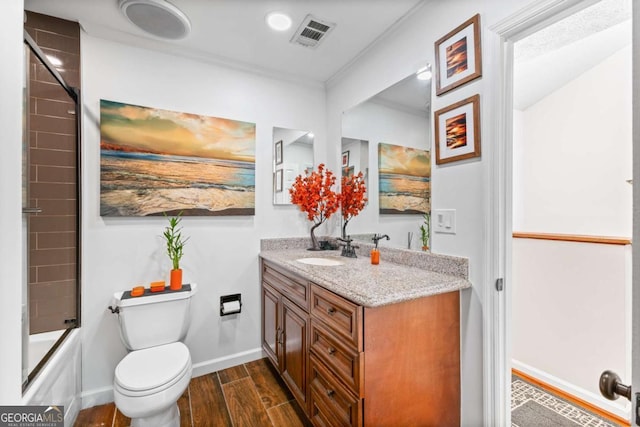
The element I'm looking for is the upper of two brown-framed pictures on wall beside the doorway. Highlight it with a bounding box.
[435,15,482,96]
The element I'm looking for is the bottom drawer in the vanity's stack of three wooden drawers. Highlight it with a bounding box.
[309,354,362,426]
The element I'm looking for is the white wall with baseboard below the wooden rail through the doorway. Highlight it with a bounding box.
[511,239,631,418]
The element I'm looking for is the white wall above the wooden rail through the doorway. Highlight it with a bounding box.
[513,46,632,237]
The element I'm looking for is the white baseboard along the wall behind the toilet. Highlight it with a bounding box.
[81,348,264,409]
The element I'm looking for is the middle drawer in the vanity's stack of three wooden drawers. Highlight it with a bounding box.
[311,319,364,397]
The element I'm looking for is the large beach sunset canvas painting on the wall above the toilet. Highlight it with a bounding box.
[100,100,256,216]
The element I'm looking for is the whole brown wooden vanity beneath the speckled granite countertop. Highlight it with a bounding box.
[260,247,468,426]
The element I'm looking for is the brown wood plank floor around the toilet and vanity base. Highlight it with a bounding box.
[74,359,311,427]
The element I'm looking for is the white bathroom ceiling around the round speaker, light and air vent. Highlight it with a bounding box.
[25,0,424,83]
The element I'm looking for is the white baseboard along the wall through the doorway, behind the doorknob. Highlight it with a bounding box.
[511,359,631,420]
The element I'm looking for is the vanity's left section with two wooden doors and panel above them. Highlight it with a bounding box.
[262,263,309,408]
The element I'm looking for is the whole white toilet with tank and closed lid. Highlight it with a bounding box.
[110,283,197,427]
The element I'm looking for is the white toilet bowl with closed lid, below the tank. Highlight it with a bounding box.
[113,342,192,427]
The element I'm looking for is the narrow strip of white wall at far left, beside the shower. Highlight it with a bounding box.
[0,0,24,405]
